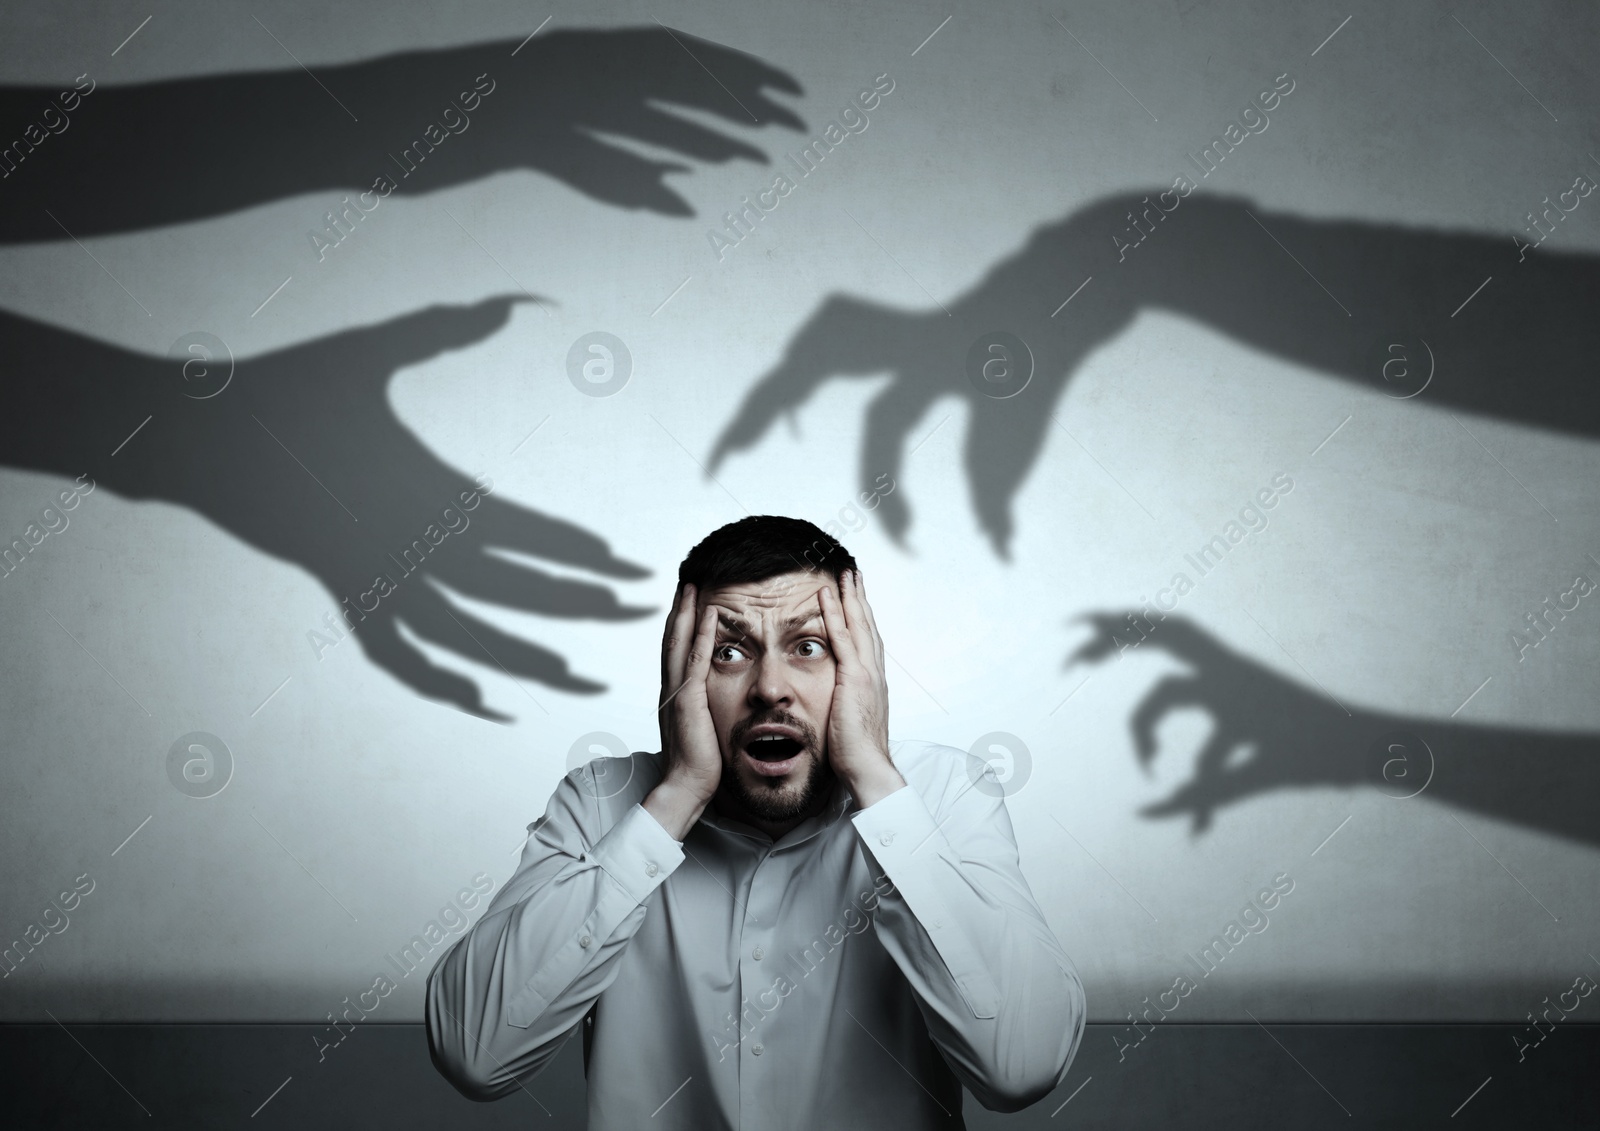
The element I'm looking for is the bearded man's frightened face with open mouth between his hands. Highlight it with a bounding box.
[698,569,838,821]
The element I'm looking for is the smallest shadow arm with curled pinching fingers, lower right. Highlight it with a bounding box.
[1069,613,1600,846]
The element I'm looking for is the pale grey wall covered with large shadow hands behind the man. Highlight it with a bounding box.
[0,2,1600,1022]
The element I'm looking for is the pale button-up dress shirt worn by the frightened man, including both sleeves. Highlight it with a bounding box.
[427,741,1085,1131]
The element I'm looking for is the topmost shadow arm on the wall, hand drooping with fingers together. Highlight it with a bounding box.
[0,26,803,243]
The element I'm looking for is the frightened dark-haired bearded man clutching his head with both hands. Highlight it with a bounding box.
[427,515,1085,1131]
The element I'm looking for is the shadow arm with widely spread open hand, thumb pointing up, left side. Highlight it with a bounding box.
[0,298,653,718]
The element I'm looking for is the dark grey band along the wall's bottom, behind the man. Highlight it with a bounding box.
[0,1022,1600,1131]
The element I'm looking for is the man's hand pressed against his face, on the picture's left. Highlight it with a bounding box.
[643,585,722,840]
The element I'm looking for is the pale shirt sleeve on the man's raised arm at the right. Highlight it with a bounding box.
[853,766,1085,1112]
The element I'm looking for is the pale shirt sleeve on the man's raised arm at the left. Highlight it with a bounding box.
[426,768,683,1099]
